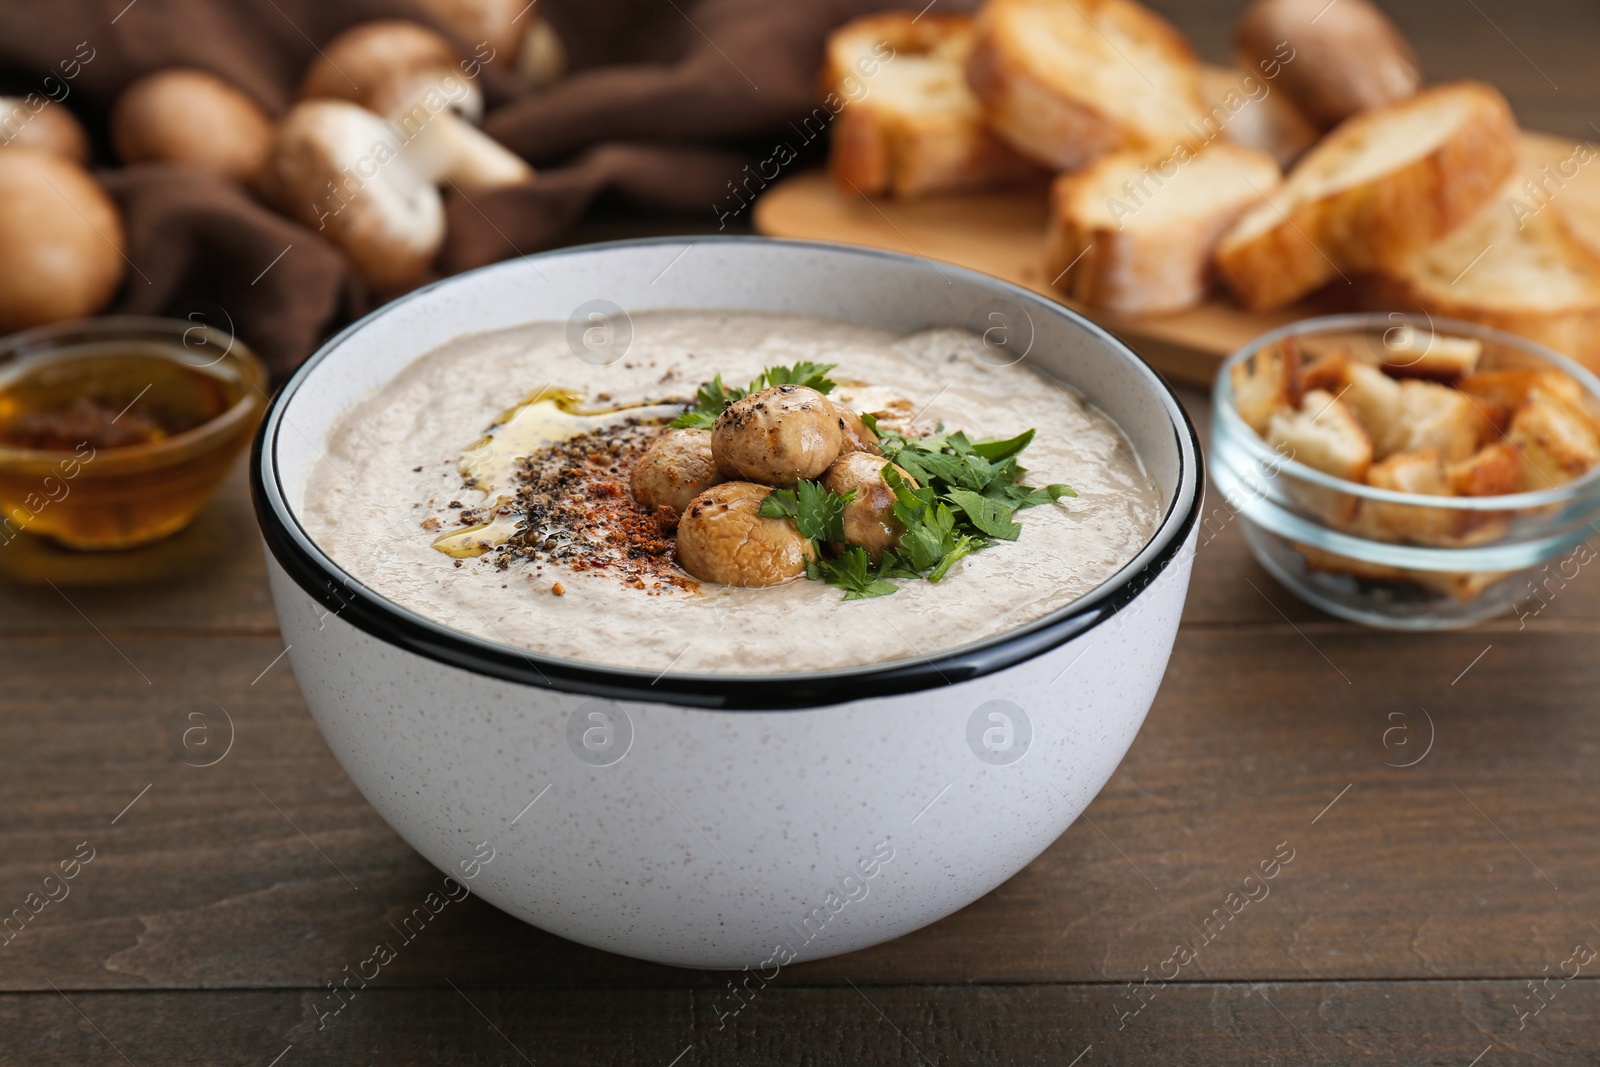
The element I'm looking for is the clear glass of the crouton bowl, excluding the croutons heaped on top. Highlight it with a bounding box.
[1208,314,1600,630]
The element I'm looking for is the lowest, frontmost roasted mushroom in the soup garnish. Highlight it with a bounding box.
[678,482,816,585]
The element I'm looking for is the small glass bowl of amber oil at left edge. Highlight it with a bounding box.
[0,317,267,552]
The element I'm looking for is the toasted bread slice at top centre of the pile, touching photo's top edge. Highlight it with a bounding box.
[966,0,1205,170]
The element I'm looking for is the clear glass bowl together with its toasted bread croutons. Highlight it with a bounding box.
[1211,314,1600,630]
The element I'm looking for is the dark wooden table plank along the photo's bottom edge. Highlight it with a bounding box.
[0,977,1600,1067]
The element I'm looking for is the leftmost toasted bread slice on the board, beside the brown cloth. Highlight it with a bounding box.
[819,11,1037,197]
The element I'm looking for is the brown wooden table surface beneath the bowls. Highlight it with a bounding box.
[0,0,1600,1067]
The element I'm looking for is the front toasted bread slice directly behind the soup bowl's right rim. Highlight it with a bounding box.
[1046,142,1282,315]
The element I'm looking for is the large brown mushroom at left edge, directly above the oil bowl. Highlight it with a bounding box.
[0,147,126,333]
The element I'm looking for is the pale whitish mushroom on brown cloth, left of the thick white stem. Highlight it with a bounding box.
[261,101,445,291]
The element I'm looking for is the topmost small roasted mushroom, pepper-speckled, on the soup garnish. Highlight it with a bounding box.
[710,386,843,486]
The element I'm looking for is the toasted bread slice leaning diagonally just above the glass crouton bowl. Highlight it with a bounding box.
[1216,82,1517,310]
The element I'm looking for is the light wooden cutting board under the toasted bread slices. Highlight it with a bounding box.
[755,133,1600,386]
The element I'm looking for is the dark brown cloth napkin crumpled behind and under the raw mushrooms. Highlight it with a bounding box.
[0,0,928,378]
